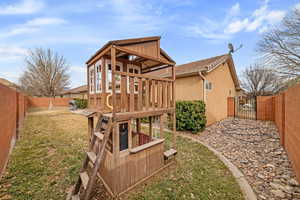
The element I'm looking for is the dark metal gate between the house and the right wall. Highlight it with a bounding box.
[234,97,257,120]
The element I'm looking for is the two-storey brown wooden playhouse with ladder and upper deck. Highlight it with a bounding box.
[69,37,177,200]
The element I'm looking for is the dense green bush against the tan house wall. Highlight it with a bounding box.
[176,101,206,133]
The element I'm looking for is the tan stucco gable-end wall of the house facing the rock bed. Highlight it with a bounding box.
[206,63,236,125]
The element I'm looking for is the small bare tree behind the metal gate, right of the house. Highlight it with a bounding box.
[241,65,284,96]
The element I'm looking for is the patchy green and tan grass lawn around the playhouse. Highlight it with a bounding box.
[0,110,243,200]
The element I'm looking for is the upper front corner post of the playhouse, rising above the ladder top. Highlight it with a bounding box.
[111,46,117,121]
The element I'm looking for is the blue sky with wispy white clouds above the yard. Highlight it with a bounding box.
[0,0,300,87]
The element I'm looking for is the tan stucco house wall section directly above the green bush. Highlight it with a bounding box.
[175,76,203,100]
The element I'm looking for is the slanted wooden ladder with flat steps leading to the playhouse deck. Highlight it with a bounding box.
[67,115,113,200]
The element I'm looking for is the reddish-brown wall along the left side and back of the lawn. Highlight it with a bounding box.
[0,84,72,178]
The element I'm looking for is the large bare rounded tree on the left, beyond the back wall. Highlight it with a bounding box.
[19,48,70,104]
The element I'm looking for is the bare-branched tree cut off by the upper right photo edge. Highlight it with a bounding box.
[258,9,300,79]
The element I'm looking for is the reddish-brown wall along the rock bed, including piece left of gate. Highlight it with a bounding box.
[227,84,300,181]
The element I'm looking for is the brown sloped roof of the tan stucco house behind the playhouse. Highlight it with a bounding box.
[150,54,240,90]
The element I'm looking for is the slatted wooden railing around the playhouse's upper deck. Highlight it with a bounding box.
[115,72,174,112]
